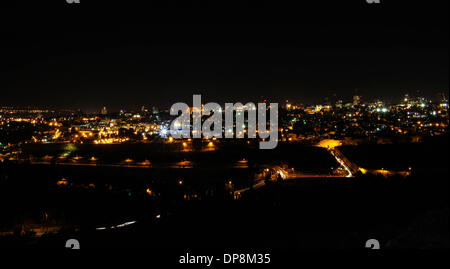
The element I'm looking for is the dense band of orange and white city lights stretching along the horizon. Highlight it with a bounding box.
[0,95,448,151]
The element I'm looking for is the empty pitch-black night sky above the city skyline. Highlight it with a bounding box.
[0,0,449,112]
